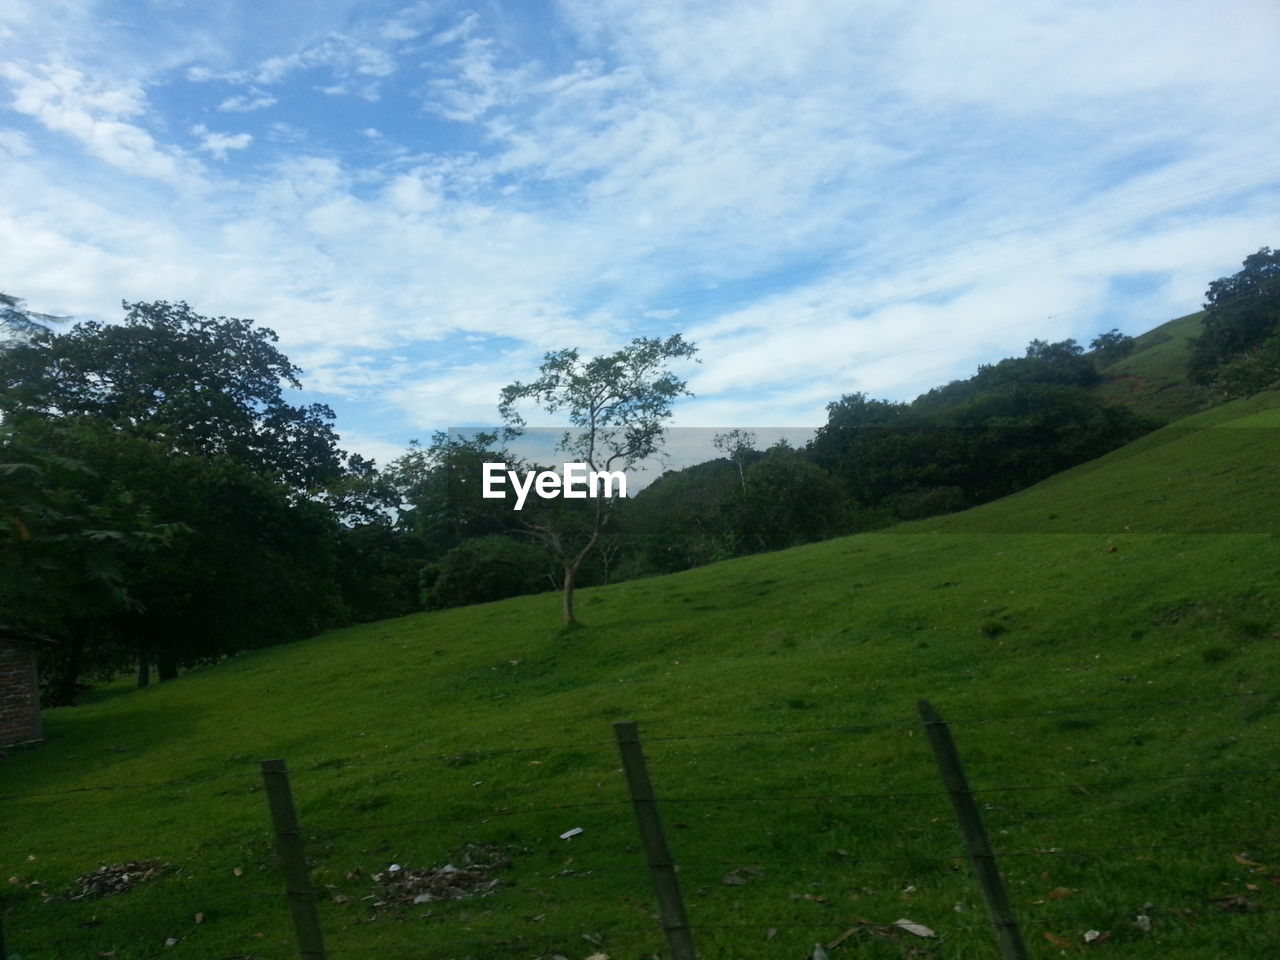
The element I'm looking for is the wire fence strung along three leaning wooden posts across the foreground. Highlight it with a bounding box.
[0,691,1280,960]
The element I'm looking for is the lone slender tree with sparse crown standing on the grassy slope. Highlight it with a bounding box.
[498,334,698,623]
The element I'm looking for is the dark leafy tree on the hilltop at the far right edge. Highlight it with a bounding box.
[1188,247,1280,393]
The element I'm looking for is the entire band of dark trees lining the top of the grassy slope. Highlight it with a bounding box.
[0,248,1280,704]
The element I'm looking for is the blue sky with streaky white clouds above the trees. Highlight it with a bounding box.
[0,0,1280,462]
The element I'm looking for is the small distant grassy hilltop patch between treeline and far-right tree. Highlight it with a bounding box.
[1097,312,1213,420]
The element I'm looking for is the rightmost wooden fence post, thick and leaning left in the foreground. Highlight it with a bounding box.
[919,700,1028,960]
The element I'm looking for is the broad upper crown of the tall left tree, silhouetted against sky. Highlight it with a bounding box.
[0,301,343,490]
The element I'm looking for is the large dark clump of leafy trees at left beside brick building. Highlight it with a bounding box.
[0,302,417,703]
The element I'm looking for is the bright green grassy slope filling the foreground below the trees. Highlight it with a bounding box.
[0,394,1280,960]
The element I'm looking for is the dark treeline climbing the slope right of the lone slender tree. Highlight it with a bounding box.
[626,340,1158,571]
